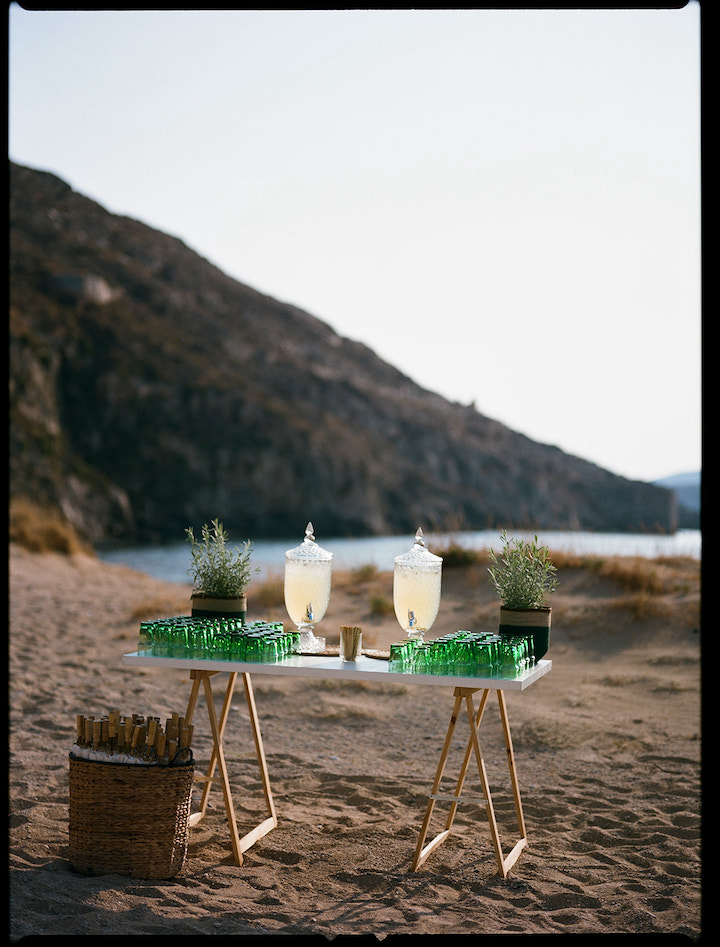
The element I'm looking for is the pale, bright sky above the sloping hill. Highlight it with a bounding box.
[9,0,701,480]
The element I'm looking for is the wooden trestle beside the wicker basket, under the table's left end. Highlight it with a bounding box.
[185,671,277,865]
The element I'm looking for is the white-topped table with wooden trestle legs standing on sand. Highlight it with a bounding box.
[122,651,552,878]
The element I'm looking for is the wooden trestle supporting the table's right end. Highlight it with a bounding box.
[411,687,527,878]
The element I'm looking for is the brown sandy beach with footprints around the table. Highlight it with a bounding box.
[9,546,702,940]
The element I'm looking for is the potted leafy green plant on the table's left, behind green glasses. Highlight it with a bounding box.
[185,519,260,623]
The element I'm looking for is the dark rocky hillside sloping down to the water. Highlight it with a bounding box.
[10,165,677,543]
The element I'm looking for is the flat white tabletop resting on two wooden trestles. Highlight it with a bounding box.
[122,651,552,691]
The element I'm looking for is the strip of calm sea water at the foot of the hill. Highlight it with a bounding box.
[97,529,702,585]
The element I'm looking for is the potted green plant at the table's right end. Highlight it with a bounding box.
[488,530,557,660]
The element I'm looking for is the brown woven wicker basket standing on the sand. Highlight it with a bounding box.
[69,753,195,879]
